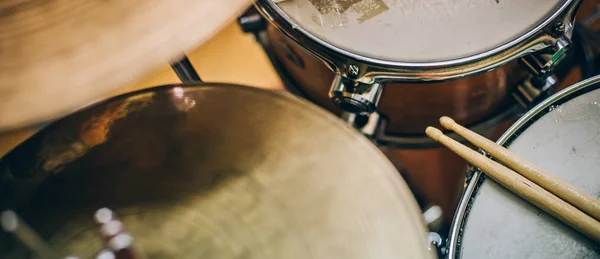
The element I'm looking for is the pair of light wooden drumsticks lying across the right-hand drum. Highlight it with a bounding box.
[425,117,600,242]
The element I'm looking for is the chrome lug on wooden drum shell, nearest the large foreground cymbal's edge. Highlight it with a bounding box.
[329,75,383,114]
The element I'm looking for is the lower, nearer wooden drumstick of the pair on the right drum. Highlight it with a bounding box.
[425,127,600,242]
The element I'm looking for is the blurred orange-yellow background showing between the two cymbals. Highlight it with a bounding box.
[0,21,283,156]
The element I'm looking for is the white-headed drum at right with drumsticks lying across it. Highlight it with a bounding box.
[449,76,600,259]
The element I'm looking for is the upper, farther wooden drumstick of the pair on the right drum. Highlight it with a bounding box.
[440,116,600,220]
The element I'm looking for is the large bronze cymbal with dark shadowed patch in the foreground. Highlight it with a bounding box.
[0,84,433,259]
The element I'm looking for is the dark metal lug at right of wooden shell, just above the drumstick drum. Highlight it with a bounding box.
[512,76,558,110]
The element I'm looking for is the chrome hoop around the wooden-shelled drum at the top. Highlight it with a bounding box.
[255,0,582,83]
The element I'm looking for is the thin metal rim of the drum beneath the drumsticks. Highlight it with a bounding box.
[447,75,600,259]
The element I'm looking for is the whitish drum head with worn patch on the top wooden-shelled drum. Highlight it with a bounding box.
[275,0,563,62]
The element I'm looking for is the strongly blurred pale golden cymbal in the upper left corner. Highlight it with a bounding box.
[0,0,252,131]
